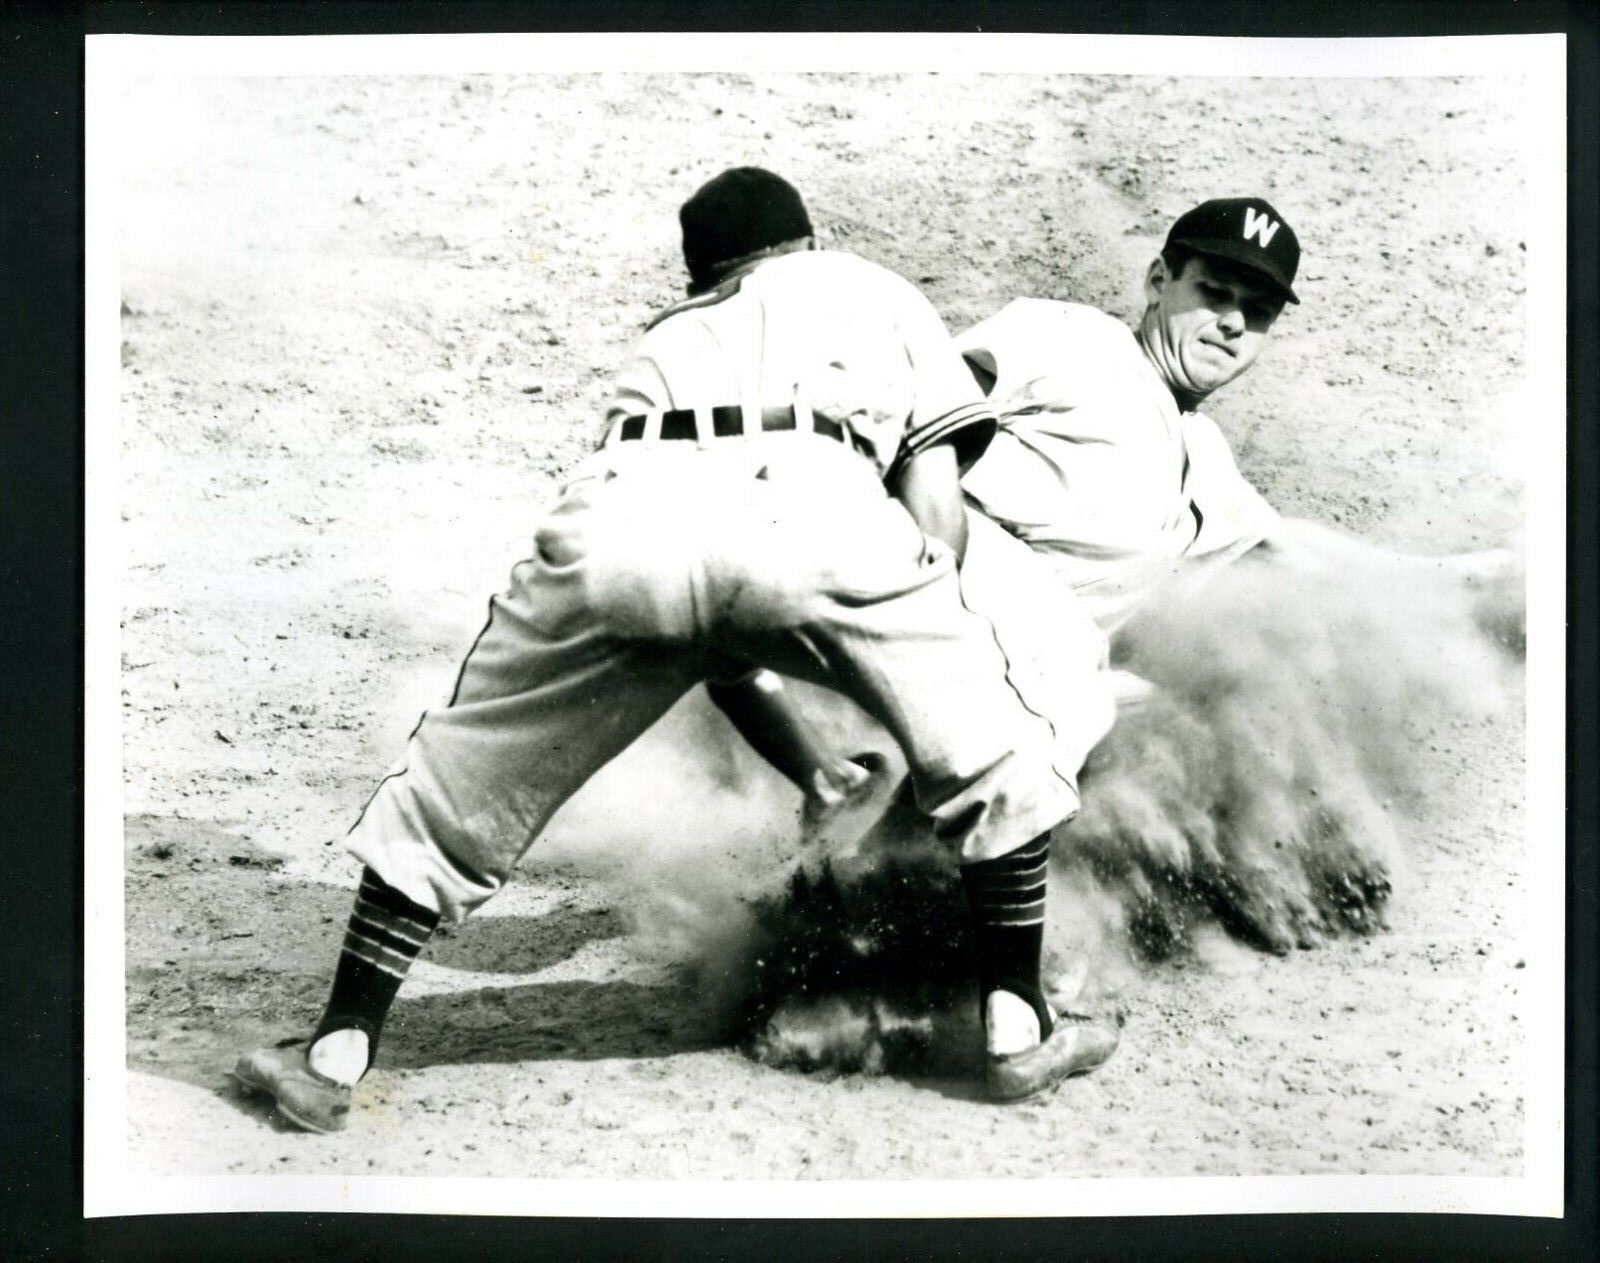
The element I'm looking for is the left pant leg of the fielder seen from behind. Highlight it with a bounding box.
[349,477,704,920]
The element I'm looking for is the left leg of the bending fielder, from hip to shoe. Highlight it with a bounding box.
[234,495,704,1132]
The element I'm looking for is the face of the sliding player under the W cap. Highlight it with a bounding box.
[1142,256,1283,395]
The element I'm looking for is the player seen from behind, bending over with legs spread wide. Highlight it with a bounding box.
[235,168,1117,1132]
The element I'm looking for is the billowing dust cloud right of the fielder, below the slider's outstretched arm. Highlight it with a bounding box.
[1056,537,1522,959]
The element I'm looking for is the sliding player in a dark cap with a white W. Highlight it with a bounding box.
[766,197,1510,845]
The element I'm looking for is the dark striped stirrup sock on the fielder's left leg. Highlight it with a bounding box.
[310,869,438,1065]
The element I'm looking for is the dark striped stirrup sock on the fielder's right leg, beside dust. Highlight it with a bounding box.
[962,832,1051,1037]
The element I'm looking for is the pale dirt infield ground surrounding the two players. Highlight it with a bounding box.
[118,77,1528,1178]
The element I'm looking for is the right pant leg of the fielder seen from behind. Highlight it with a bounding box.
[694,483,1100,861]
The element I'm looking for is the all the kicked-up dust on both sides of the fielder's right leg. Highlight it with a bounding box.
[555,551,1523,1073]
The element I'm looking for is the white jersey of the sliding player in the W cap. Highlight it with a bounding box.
[955,298,1278,631]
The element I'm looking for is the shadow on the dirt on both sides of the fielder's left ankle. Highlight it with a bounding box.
[126,816,707,1093]
